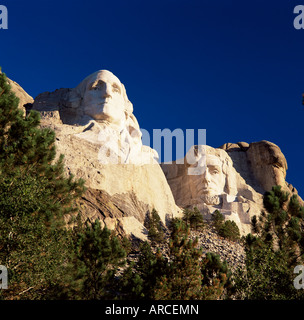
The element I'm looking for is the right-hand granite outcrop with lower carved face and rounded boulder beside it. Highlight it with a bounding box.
[161,141,303,235]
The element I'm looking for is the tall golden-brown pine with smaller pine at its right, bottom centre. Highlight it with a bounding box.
[155,219,230,300]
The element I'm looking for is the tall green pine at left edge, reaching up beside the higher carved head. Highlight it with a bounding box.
[0,73,84,223]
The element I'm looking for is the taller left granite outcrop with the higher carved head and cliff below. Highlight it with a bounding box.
[33,70,181,239]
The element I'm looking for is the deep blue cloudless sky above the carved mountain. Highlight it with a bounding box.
[0,0,304,197]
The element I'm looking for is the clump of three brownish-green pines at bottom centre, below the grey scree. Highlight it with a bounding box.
[120,218,231,300]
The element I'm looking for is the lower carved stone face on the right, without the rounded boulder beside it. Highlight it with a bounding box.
[162,146,263,234]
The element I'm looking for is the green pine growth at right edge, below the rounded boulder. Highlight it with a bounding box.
[235,186,304,300]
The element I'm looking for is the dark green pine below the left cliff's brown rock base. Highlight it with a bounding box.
[71,219,126,300]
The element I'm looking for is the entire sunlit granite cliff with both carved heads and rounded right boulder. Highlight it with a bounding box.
[10,70,304,240]
